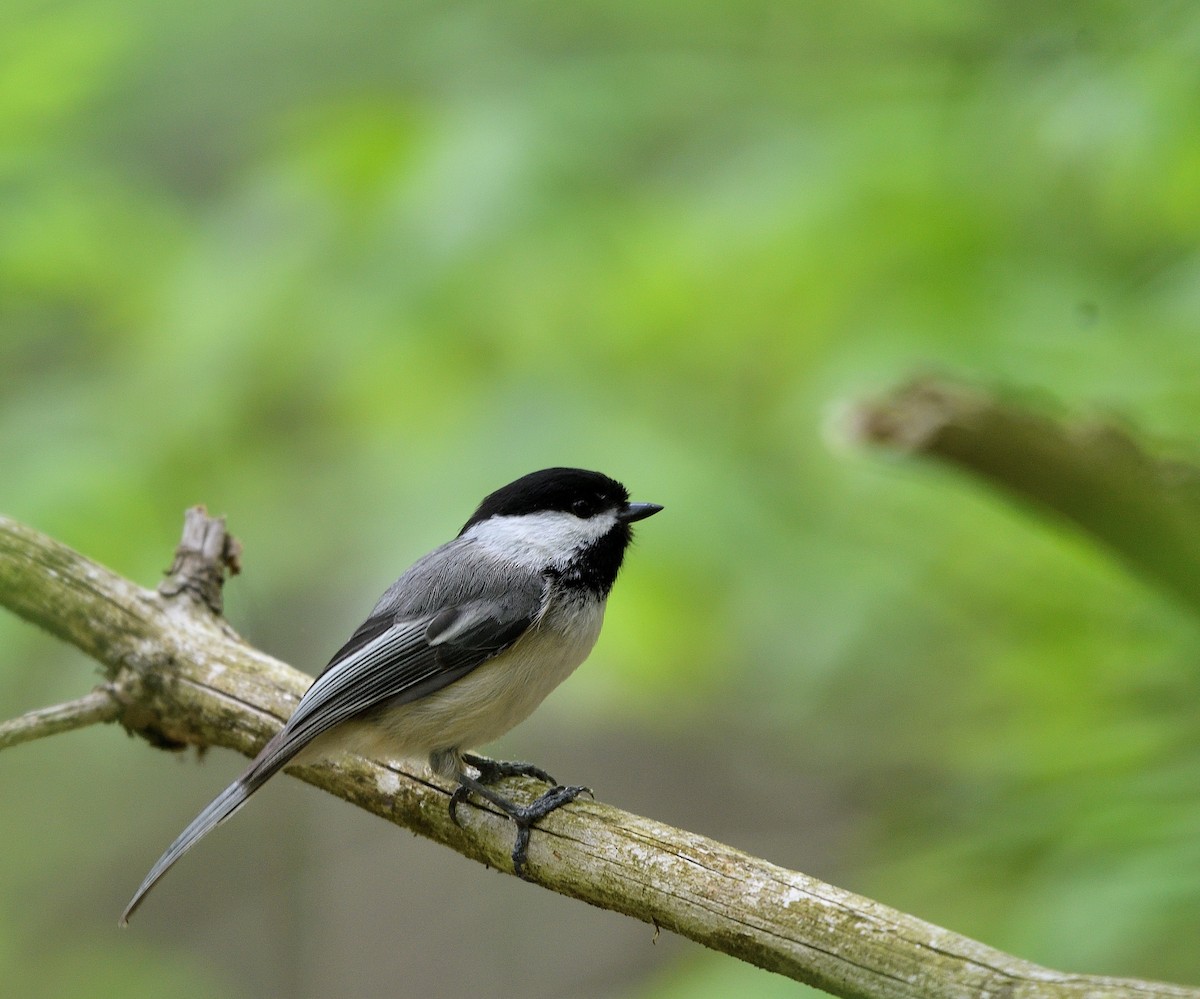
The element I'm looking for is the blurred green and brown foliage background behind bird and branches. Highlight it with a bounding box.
[0,0,1200,999]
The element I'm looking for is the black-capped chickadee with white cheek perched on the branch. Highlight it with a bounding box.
[121,468,662,926]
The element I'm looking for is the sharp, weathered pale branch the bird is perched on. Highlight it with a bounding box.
[0,510,1200,999]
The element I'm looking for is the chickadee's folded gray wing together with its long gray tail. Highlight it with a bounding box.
[121,542,548,925]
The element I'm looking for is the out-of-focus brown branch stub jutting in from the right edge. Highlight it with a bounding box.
[852,378,1200,611]
